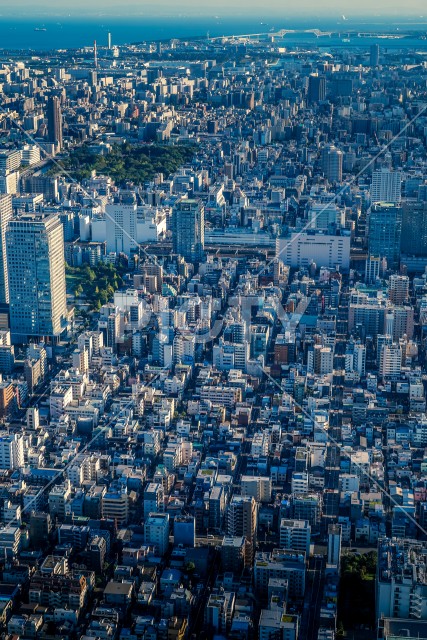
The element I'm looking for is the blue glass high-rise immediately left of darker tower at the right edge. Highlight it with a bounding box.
[368,202,402,269]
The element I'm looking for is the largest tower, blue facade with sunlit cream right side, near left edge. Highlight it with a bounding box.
[6,214,67,343]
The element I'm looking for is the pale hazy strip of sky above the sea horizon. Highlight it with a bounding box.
[0,0,427,20]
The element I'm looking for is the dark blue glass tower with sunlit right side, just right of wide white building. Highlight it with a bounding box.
[171,198,205,262]
